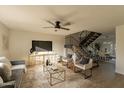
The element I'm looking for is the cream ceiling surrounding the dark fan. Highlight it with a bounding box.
[0,5,124,35]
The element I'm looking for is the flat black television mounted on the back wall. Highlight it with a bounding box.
[32,40,52,51]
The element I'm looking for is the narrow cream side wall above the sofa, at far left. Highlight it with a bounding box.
[0,23,9,58]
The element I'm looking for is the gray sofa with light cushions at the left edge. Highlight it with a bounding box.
[0,59,26,88]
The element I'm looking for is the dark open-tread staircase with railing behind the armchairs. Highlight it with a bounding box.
[65,31,101,59]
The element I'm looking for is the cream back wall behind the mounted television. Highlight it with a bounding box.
[9,31,64,62]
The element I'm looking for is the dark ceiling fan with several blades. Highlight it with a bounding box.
[43,20,71,31]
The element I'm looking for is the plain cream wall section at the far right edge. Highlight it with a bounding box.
[116,25,124,74]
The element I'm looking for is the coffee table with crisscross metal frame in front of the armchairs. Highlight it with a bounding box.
[46,66,66,86]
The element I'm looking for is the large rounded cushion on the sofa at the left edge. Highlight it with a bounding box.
[0,63,12,82]
